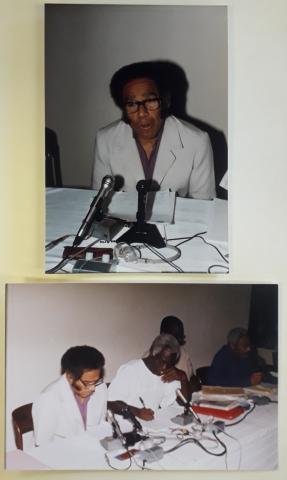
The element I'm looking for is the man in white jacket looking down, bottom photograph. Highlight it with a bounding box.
[32,346,107,446]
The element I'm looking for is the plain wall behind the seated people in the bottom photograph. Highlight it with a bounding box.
[6,284,250,449]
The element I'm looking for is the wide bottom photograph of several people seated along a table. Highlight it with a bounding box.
[5,283,278,471]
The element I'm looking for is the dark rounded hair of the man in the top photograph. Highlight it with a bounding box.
[110,61,170,116]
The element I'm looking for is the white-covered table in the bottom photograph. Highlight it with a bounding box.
[7,403,277,470]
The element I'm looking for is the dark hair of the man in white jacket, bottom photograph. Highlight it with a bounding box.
[61,345,105,380]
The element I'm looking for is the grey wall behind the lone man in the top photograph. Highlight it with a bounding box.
[45,5,227,186]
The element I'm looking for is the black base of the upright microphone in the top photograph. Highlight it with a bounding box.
[117,223,166,248]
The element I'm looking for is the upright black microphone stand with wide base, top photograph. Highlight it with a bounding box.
[116,180,166,248]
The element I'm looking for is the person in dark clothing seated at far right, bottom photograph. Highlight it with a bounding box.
[208,327,263,387]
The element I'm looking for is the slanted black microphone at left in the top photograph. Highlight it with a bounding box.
[73,175,115,247]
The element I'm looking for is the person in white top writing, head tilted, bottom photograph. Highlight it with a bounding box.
[108,334,190,420]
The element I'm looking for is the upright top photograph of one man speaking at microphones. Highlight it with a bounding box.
[45,4,230,274]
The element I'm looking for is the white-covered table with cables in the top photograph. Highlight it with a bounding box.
[46,188,228,273]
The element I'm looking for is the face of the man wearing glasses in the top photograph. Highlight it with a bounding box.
[123,78,163,143]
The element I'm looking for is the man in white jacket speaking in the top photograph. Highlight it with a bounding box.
[92,62,215,199]
